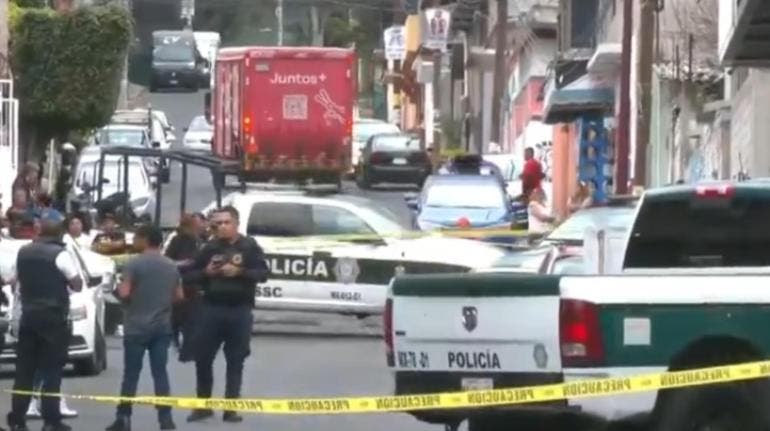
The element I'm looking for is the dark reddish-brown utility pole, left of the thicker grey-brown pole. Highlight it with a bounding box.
[615,0,634,195]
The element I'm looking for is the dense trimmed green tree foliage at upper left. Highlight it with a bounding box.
[11,6,133,136]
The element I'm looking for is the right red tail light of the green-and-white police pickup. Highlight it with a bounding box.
[559,299,604,367]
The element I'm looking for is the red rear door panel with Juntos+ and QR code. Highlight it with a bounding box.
[244,53,355,162]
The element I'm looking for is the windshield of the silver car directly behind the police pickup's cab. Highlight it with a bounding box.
[547,207,635,243]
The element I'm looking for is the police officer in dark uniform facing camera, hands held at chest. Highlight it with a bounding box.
[185,206,268,422]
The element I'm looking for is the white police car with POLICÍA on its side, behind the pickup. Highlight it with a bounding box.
[200,191,506,317]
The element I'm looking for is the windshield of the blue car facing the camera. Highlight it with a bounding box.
[425,182,505,209]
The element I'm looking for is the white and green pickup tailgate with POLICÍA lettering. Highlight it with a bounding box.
[392,273,561,373]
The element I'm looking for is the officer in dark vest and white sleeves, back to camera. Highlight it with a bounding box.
[8,220,83,431]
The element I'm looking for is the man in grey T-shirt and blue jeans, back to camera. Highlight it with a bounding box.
[107,225,184,431]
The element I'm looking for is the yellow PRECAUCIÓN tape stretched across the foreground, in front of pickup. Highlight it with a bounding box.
[9,361,770,415]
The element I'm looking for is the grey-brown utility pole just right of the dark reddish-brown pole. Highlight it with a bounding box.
[634,0,657,187]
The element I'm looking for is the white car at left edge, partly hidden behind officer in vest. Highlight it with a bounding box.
[0,238,115,375]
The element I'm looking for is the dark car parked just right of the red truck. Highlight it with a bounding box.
[356,133,433,189]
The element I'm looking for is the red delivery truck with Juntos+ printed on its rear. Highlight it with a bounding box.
[211,47,357,184]
